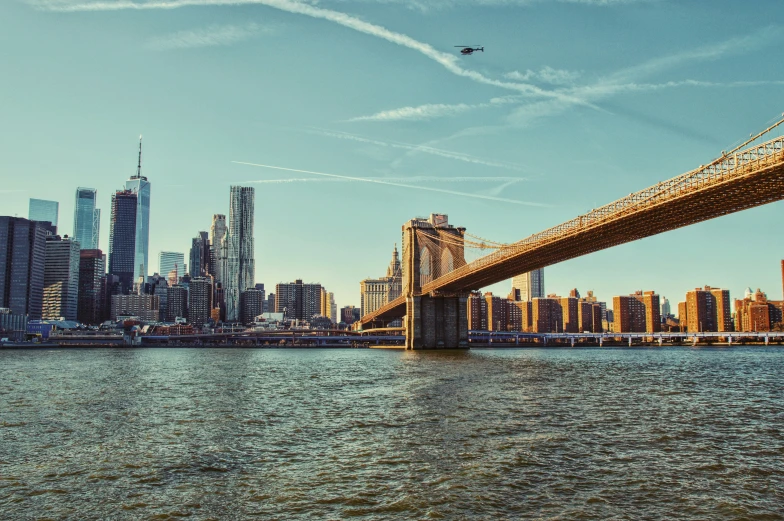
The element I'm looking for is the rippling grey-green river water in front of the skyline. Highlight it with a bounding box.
[0,348,784,519]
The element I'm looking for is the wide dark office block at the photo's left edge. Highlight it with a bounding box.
[0,217,47,320]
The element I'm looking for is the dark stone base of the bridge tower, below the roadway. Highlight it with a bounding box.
[406,295,468,349]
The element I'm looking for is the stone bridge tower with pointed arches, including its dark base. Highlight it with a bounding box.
[403,214,468,349]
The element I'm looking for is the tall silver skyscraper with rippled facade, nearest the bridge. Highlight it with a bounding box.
[224,186,256,321]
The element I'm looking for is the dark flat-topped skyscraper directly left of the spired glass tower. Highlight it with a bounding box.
[109,190,138,295]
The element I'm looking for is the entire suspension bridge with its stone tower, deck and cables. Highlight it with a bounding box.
[361,119,784,349]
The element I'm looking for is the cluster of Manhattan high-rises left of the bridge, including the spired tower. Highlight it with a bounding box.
[0,139,346,339]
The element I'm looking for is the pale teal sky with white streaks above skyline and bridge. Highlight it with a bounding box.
[0,0,784,308]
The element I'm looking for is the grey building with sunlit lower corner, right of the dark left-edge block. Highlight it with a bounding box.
[41,235,79,320]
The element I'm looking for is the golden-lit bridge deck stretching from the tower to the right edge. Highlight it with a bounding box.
[361,129,784,325]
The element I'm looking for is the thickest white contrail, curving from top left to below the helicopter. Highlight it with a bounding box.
[29,0,598,108]
